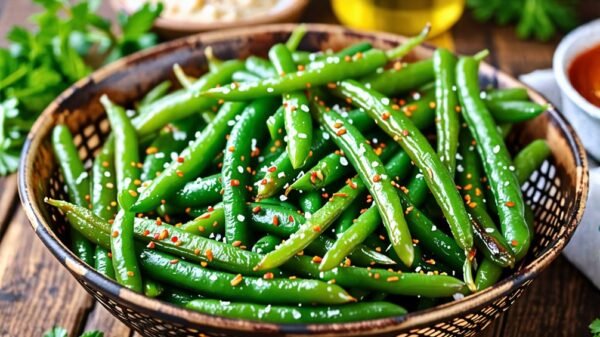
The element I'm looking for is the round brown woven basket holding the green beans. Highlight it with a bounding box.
[19,25,588,337]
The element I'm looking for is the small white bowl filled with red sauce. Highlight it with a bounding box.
[553,19,600,160]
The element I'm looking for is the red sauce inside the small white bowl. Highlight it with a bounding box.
[569,45,600,107]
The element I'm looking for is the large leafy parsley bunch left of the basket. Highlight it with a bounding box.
[0,0,162,175]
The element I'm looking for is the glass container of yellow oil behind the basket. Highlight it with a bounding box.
[331,0,465,36]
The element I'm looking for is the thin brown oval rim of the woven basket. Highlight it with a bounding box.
[18,24,588,334]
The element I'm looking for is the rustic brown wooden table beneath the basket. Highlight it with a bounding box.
[0,0,600,337]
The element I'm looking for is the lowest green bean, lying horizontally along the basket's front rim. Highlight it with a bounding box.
[186,299,406,324]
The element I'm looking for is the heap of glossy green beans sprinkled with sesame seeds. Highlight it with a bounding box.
[46,26,550,324]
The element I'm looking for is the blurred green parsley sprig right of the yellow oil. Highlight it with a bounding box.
[467,0,579,41]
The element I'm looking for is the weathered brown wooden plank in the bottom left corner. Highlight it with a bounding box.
[0,209,93,337]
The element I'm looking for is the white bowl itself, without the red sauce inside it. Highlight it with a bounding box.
[553,19,600,160]
